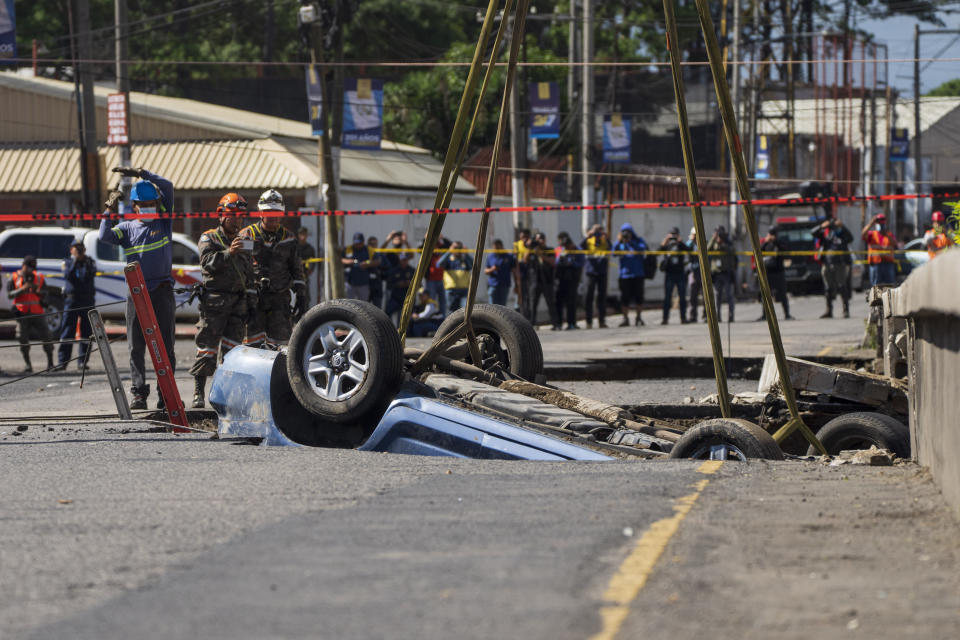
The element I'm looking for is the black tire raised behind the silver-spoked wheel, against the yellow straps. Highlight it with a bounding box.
[435,304,543,381]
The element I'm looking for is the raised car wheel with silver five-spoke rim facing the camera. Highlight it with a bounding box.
[287,299,403,424]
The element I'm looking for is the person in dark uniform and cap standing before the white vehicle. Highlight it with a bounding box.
[57,242,97,371]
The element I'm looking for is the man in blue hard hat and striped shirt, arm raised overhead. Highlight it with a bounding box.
[99,167,177,409]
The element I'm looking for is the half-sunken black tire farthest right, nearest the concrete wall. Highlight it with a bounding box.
[807,411,910,458]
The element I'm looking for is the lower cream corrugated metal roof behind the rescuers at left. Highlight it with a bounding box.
[0,138,474,193]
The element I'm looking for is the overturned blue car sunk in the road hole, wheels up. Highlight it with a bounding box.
[210,299,906,460]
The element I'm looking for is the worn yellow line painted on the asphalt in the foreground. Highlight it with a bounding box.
[591,460,723,640]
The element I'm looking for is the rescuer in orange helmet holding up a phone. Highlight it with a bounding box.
[190,193,257,409]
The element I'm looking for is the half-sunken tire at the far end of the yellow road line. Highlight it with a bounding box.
[670,418,783,461]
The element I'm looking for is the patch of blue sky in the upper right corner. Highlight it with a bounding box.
[857,15,960,97]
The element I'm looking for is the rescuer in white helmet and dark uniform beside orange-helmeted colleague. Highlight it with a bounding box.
[240,189,307,349]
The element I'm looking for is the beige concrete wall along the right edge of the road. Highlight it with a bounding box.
[883,249,960,517]
